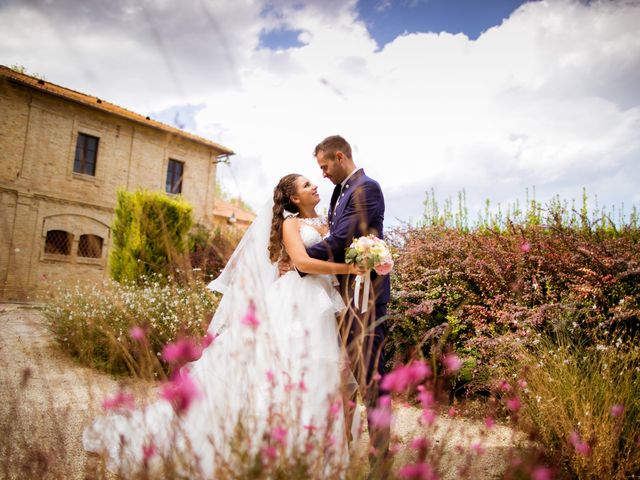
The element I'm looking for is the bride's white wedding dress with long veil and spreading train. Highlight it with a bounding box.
[83,209,348,478]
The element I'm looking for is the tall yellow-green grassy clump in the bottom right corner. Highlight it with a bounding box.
[510,333,640,479]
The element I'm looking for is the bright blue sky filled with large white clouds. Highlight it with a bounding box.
[0,0,640,226]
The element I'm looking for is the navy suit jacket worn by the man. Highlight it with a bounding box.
[307,170,391,304]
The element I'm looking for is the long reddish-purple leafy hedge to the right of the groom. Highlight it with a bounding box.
[387,192,640,389]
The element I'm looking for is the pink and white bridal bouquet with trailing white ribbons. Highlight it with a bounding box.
[345,235,393,313]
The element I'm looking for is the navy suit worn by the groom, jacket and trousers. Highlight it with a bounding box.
[307,169,391,449]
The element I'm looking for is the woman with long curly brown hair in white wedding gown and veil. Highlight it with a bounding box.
[83,174,362,478]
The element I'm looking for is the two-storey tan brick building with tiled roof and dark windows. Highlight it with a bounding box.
[0,66,238,300]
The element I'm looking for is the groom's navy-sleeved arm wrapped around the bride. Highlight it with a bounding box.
[307,182,384,262]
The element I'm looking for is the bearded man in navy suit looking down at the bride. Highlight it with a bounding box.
[307,135,390,469]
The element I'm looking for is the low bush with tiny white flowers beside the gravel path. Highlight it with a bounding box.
[46,277,218,378]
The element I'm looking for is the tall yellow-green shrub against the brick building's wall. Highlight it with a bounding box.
[110,190,192,282]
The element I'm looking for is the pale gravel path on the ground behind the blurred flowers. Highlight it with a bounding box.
[0,304,521,479]
